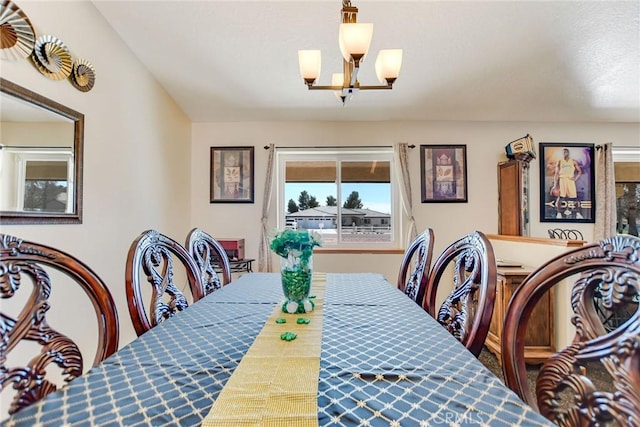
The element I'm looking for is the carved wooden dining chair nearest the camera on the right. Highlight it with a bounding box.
[502,235,640,427]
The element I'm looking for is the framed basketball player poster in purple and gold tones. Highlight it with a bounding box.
[539,142,596,223]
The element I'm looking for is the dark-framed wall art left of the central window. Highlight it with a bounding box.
[209,147,254,203]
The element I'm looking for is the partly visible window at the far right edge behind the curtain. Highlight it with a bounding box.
[613,147,640,236]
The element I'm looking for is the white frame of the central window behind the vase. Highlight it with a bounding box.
[275,147,402,250]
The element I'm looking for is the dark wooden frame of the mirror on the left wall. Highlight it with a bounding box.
[0,78,84,224]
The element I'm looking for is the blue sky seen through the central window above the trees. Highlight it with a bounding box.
[284,182,391,214]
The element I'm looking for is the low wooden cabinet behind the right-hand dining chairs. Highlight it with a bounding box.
[485,267,555,364]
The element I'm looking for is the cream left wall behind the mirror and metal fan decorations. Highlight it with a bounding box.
[0,1,191,352]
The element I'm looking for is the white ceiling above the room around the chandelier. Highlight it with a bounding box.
[93,0,640,122]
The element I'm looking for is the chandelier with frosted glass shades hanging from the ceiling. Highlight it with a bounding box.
[298,0,402,105]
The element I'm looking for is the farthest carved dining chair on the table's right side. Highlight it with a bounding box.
[398,228,434,305]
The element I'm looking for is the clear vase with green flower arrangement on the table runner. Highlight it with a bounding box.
[270,229,322,313]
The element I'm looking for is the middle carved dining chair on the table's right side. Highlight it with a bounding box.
[423,231,497,357]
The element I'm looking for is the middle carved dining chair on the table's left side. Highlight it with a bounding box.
[125,230,204,336]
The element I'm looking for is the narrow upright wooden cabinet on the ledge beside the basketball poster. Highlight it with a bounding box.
[498,159,529,236]
